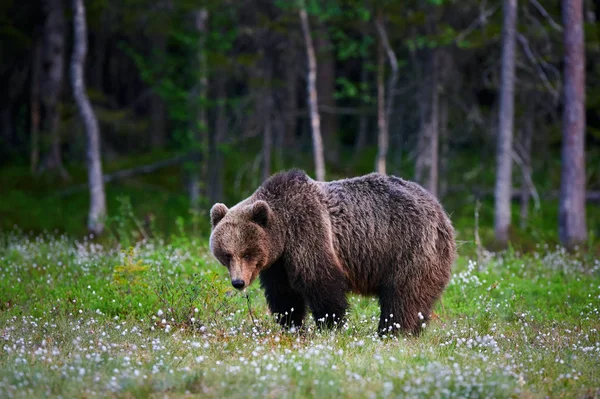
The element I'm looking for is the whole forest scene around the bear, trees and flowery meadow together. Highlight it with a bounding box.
[0,0,600,398]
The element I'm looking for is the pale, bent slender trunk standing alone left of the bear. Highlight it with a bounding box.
[71,0,106,234]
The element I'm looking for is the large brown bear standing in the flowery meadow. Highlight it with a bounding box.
[210,169,456,334]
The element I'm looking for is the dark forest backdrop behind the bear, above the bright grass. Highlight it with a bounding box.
[0,0,600,248]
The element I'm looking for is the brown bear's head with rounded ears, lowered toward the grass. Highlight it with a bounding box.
[210,200,281,290]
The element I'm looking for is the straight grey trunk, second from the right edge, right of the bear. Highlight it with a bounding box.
[494,0,517,247]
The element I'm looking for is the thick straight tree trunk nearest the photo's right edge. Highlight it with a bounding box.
[558,0,587,250]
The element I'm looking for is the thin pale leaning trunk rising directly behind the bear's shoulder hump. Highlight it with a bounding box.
[300,1,325,181]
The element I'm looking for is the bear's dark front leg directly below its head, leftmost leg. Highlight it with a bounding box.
[260,262,306,328]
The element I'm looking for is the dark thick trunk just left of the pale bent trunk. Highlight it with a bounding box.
[40,0,68,179]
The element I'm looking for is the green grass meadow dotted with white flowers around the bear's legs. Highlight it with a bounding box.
[0,231,600,398]
